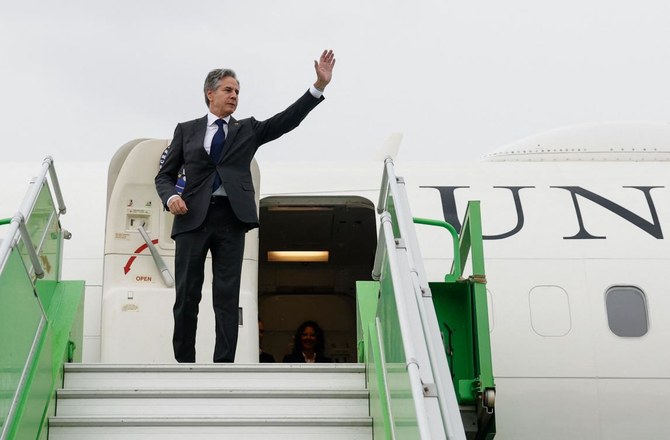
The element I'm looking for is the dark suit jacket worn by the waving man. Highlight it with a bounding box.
[155,91,323,238]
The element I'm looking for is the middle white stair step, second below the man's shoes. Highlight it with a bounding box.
[57,389,368,417]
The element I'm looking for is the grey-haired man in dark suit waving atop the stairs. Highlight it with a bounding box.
[156,50,335,362]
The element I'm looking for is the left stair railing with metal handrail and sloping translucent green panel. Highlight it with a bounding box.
[0,157,65,440]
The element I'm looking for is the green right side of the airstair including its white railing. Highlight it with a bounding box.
[357,158,495,440]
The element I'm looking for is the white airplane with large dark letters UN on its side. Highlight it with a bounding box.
[2,122,670,440]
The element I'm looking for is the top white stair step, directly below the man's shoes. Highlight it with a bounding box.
[64,364,365,390]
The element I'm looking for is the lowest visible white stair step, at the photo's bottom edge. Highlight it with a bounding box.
[49,417,372,440]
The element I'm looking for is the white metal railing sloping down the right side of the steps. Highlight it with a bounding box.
[372,158,465,439]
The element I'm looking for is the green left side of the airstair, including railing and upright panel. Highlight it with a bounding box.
[0,157,84,440]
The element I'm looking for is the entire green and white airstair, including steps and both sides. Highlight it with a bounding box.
[0,159,495,440]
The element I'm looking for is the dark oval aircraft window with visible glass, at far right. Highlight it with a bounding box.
[605,286,649,338]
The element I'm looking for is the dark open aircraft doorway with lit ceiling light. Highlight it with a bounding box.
[258,196,377,362]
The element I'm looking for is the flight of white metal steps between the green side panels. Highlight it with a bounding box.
[49,364,372,440]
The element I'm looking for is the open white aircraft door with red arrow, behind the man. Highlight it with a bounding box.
[101,139,260,363]
